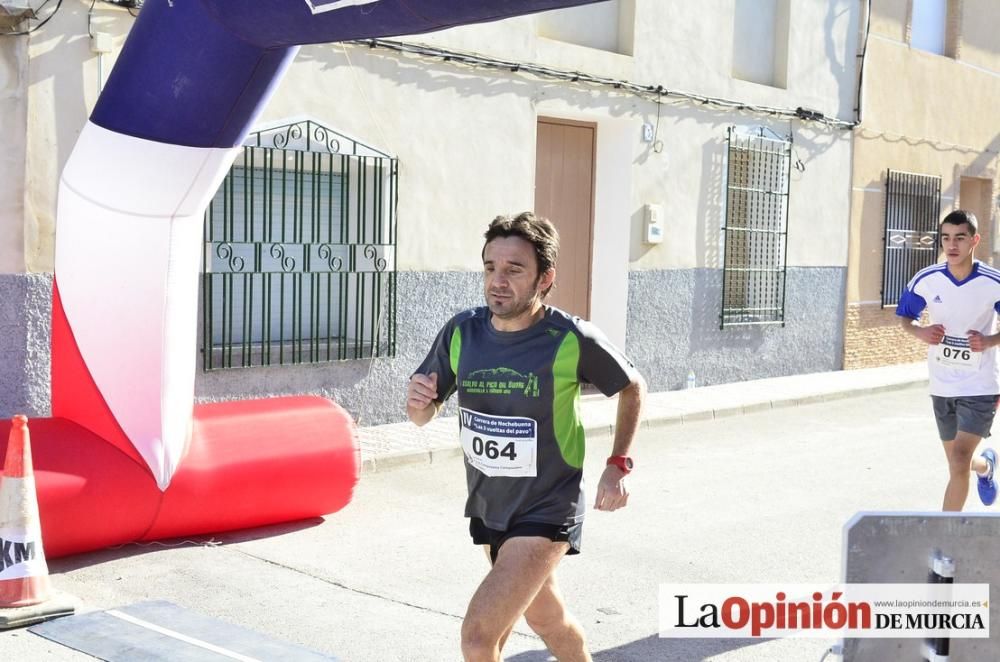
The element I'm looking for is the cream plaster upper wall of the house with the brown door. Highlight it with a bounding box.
[4,0,858,289]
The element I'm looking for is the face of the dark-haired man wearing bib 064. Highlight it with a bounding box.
[483,237,552,320]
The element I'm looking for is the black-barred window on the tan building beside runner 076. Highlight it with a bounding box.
[882,170,941,306]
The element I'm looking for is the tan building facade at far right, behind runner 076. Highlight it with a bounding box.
[844,0,1000,368]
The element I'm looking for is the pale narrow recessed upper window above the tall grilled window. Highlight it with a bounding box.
[733,0,791,88]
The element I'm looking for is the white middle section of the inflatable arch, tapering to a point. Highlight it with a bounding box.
[55,122,241,490]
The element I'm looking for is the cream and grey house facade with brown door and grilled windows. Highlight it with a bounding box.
[0,0,860,424]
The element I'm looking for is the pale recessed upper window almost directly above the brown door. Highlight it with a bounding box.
[538,0,635,55]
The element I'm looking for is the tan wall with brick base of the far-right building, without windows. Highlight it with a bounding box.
[844,0,1000,367]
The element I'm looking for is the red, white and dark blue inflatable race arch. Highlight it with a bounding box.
[0,0,595,557]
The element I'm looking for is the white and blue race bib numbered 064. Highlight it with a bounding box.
[458,408,538,478]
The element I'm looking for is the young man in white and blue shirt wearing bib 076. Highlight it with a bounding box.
[896,209,1000,511]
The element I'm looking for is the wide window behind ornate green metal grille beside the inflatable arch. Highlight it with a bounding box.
[202,121,398,370]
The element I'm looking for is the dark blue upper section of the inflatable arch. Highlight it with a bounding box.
[90,0,597,147]
